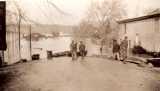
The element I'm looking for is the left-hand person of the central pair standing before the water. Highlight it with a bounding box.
[70,40,77,60]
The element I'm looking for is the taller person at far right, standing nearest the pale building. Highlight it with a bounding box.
[120,36,128,63]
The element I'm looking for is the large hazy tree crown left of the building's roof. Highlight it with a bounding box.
[76,0,126,44]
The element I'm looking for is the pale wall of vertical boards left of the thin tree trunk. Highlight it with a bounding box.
[4,25,20,64]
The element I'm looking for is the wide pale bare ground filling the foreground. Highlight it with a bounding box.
[0,57,160,91]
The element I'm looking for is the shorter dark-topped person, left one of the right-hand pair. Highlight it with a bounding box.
[112,40,120,60]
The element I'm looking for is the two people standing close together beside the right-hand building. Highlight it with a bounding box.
[112,36,128,62]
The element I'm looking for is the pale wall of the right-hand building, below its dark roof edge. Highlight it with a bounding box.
[119,18,160,51]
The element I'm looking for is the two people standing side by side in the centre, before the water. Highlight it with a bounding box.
[70,40,86,60]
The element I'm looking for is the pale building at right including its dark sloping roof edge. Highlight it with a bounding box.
[118,13,160,52]
